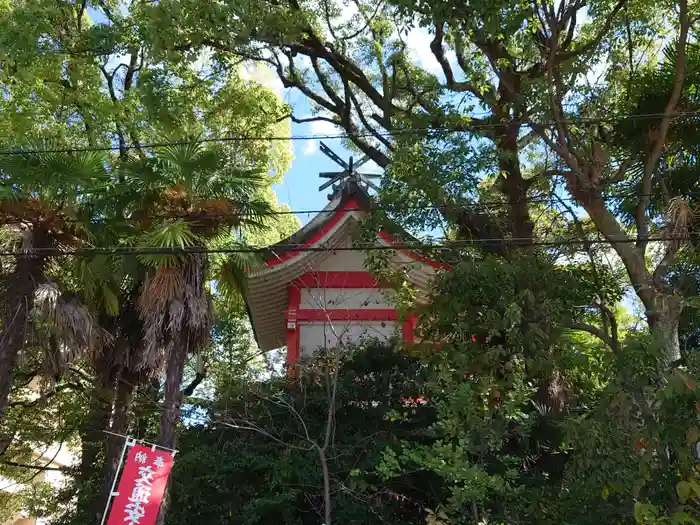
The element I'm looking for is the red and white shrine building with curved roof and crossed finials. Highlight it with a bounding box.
[247,143,446,366]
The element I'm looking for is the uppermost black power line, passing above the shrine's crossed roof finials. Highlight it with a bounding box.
[0,111,700,156]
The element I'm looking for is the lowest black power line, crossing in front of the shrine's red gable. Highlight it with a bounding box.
[0,231,700,257]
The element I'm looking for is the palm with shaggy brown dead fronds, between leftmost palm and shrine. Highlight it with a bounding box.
[116,144,271,448]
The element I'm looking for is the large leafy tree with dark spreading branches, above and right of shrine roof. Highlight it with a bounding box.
[144,0,698,362]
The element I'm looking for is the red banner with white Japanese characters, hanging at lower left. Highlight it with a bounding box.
[107,445,178,525]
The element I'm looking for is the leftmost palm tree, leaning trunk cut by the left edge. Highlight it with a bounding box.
[0,145,110,419]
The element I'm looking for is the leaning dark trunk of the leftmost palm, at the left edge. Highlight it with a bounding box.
[0,255,44,421]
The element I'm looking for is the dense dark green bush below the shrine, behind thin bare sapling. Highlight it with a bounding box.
[168,344,439,525]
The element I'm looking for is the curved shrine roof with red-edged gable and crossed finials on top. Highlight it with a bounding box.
[246,143,446,351]
